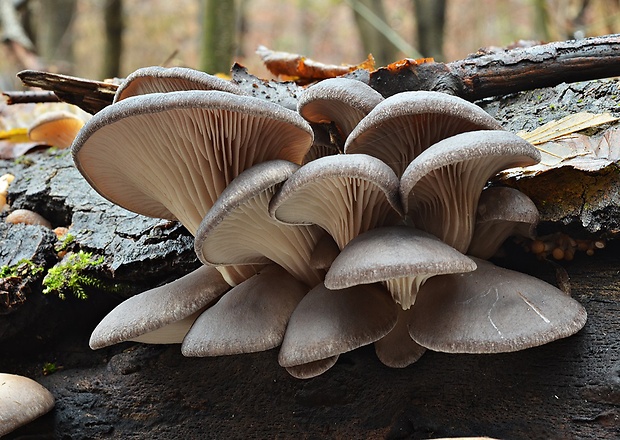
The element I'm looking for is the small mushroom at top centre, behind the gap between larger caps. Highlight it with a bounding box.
[297,78,383,141]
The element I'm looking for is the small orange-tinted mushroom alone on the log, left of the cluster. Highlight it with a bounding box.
[28,111,84,148]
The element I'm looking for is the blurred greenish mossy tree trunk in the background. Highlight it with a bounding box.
[200,0,237,73]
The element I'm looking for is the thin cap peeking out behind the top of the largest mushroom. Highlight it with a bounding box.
[114,66,245,102]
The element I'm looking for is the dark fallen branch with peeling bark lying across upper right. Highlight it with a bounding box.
[370,34,620,101]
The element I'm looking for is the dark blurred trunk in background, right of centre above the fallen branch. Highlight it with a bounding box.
[413,0,446,61]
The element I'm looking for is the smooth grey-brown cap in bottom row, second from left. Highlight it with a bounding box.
[181,264,308,356]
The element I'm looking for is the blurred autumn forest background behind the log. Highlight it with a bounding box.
[0,0,620,89]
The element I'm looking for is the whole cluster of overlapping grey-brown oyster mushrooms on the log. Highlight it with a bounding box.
[72,68,586,378]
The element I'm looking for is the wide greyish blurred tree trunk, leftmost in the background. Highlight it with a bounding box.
[33,0,77,73]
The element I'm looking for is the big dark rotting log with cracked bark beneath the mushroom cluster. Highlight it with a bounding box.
[0,81,620,440]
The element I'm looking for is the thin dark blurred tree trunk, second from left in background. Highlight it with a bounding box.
[101,0,123,79]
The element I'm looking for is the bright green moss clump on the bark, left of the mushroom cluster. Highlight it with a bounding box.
[43,251,121,299]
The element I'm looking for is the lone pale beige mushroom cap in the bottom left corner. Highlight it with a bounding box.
[0,373,54,437]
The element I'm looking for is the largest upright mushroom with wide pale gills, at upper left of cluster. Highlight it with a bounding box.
[72,91,313,233]
